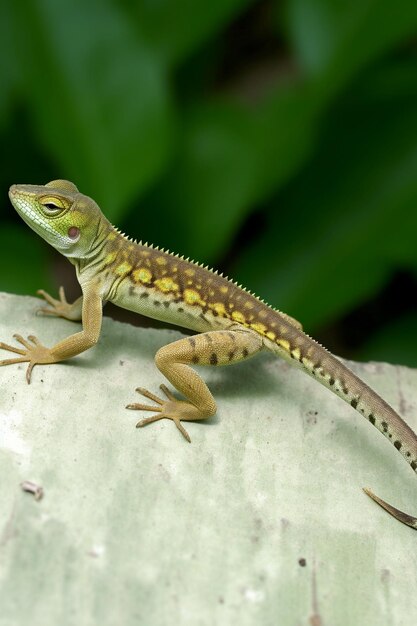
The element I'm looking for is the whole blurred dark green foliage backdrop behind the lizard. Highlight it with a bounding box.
[0,0,417,365]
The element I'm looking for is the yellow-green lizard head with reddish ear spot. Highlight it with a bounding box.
[9,180,107,258]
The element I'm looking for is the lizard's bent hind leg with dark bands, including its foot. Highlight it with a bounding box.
[126,327,263,441]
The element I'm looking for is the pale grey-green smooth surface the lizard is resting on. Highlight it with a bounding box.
[0,294,417,626]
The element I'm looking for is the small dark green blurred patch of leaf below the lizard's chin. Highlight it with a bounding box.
[0,222,52,295]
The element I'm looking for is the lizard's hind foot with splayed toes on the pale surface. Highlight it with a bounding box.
[126,385,196,443]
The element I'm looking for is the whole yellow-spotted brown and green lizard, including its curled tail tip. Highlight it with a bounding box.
[0,180,417,530]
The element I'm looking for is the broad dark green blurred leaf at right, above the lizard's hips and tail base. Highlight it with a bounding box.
[235,56,417,328]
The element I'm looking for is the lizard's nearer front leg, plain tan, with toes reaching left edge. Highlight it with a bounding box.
[0,284,102,383]
